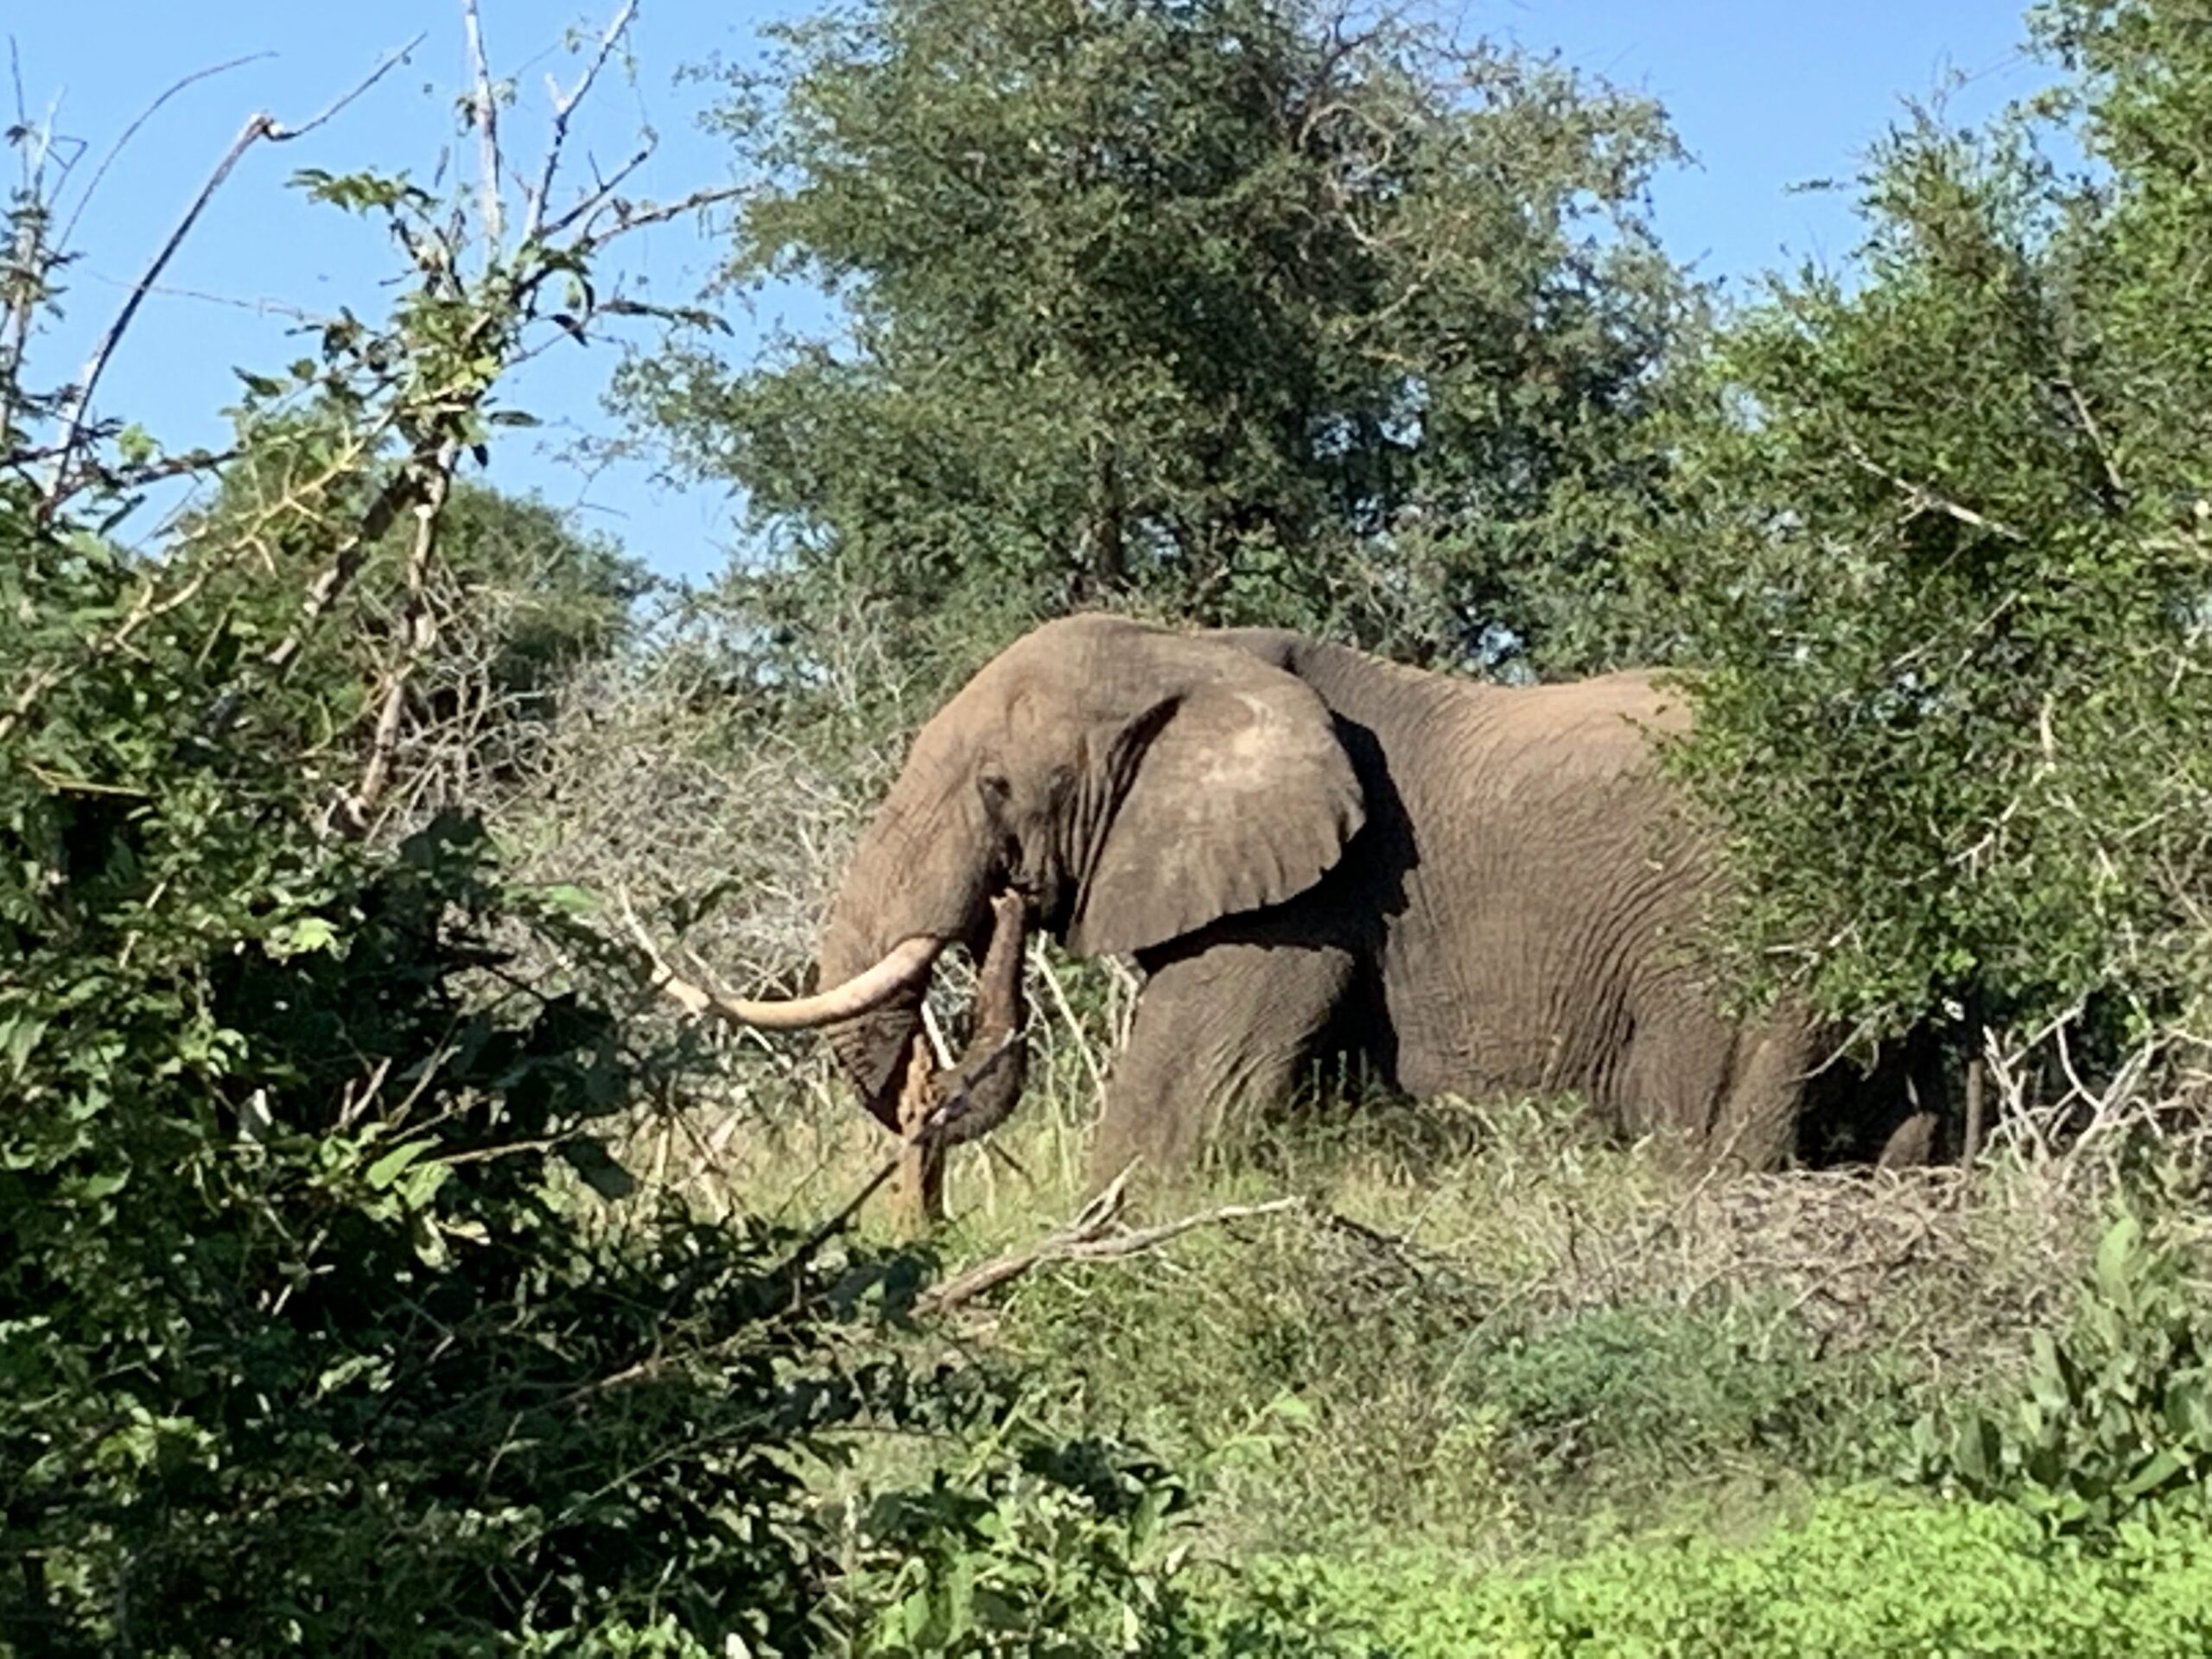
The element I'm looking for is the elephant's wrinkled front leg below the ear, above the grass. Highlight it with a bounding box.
[1090,936,1356,1188]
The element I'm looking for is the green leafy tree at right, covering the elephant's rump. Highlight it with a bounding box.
[1642,0,2212,1079]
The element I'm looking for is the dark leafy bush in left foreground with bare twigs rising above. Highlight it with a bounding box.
[0,55,1230,1655]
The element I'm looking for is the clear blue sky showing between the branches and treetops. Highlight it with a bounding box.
[0,0,2042,577]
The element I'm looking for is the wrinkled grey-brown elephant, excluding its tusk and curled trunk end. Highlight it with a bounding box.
[821,617,1927,1179]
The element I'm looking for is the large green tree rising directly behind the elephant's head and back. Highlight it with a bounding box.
[621,0,1697,681]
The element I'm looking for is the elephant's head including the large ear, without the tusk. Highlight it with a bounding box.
[821,617,1363,1123]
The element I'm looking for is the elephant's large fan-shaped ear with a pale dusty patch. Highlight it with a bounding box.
[1068,659,1365,956]
